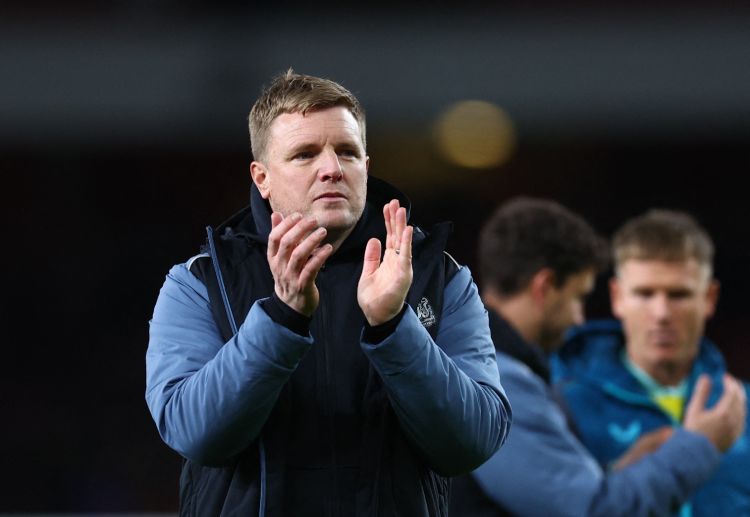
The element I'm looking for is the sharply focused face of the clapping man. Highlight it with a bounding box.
[250,106,370,234]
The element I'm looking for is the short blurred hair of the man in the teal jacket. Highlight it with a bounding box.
[612,209,714,277]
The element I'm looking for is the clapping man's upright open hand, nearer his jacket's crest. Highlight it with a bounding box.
[357,199,414,326]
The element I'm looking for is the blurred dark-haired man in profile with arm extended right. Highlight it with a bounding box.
[451,198,744,517]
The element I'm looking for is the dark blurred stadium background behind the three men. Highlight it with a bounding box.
[5,0,750,512]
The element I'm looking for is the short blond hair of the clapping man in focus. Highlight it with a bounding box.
[248,68,367,160]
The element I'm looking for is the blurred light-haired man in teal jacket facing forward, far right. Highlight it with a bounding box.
[558,210,750,516]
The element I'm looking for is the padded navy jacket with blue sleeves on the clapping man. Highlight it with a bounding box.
[147,178,509,517]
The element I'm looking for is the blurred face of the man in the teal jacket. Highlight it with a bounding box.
[610,259,718,375]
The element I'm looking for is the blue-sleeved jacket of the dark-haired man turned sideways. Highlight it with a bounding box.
[450,309,721,517]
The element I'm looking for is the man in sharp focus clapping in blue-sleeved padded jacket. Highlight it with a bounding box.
[146,70,510,517]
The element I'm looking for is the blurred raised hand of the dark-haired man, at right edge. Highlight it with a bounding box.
[683,374,747,452]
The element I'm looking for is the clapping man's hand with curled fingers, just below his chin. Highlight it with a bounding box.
[266,212,333,316]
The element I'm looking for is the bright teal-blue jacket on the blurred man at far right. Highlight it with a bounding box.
[552,321,750,517]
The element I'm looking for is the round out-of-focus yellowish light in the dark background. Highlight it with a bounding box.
[435,100,516,169]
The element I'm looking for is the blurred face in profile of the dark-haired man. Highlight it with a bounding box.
[538,269,596,351]
